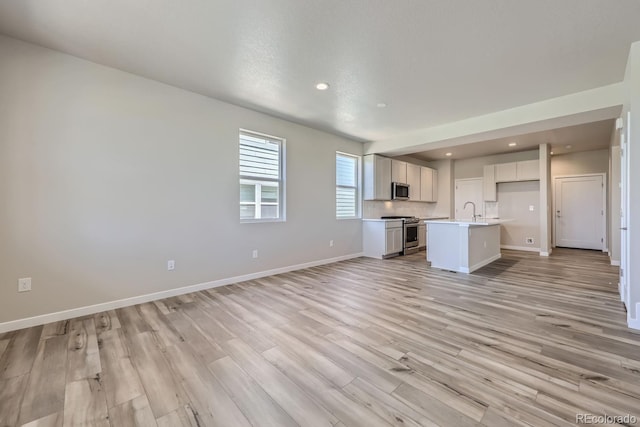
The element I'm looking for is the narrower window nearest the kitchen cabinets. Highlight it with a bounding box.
[336,152,360,219]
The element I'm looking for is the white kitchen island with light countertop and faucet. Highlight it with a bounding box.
[425,218,510,273]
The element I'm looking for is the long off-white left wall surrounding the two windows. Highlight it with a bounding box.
[0,37,362,323]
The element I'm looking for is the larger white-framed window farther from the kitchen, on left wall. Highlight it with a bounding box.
[240,130,284,222]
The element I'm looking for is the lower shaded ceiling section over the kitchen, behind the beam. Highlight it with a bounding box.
[413,119,615,160]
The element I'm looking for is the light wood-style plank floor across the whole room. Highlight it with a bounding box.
[0,249,640,427]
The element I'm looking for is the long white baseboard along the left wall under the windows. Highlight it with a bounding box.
[0,253,364,333]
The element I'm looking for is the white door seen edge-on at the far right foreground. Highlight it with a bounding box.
[612,112,631,310]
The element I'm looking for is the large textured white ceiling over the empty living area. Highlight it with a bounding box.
[0,0,640,149]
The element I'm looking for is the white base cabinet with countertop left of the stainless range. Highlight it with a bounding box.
[362,219,404,258]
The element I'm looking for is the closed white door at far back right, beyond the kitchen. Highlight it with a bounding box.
[555,175,605,250]
